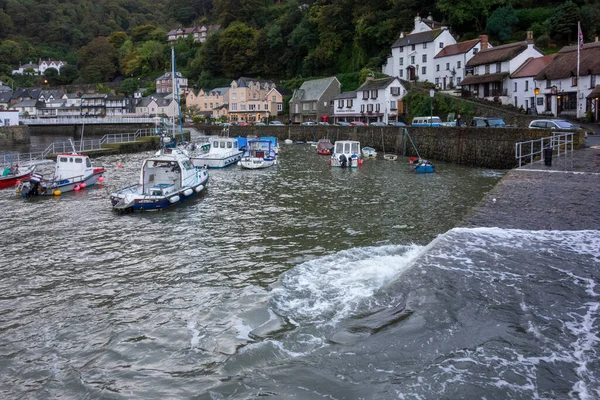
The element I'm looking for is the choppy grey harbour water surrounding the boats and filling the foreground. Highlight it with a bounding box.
[0,145,600,399]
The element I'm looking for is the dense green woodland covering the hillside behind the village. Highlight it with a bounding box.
[0,0,600,93]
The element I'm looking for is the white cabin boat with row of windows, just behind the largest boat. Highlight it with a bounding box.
[188,136,244,168]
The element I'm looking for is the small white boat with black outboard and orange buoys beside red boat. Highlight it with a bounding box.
[17,152,104,197]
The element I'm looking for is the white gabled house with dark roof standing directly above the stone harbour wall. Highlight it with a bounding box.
[356,77,406,124]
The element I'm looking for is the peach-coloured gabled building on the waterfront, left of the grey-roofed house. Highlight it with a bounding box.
[229,77,283,123]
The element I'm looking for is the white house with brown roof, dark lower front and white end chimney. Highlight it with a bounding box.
[460,32,545,104]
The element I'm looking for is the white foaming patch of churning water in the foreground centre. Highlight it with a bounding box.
[272,245,425,325]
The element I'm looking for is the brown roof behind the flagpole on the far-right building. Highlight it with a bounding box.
[535,42,600,80]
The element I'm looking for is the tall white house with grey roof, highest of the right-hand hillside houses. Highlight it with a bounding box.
[382,14,456,83]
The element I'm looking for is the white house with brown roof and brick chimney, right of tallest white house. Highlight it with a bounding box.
[433,35,492,90]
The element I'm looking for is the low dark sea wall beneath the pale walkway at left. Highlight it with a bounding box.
[29,123,155,140]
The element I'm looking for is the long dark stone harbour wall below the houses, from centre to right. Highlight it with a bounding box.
[199,125,585,169]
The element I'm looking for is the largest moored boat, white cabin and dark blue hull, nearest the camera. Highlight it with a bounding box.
[110,148,208,212]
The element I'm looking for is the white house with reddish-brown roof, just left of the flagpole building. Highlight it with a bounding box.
[508,54,556,114]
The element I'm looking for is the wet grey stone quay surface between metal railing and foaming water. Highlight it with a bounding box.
[465,133,600,230]
